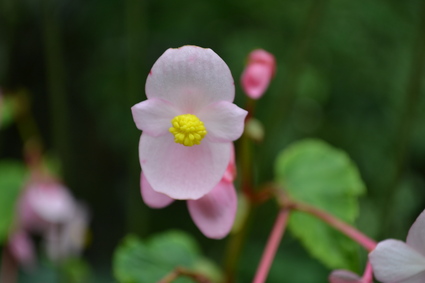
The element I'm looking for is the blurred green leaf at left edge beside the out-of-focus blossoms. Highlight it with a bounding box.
[0,161,26,243]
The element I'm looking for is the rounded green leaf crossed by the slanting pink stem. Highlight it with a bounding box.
[275,139,365,269]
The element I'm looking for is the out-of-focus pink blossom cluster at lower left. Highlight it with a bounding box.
[8,179,88,267]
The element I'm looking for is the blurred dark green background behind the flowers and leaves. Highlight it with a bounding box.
[0,0,425,283]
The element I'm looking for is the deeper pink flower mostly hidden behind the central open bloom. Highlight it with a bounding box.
[141,150,237,239]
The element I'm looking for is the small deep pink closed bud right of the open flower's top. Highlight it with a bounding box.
[241,49,276,99]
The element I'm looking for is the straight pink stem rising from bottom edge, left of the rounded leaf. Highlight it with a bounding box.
[253,208,289,283]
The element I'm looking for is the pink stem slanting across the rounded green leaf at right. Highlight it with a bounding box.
[289,202,376,251]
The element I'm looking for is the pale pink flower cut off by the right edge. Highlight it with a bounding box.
[369,211,425,283]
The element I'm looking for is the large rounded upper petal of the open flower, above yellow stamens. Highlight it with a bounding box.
[146,46,235,114]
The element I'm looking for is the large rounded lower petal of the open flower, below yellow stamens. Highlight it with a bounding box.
[139,133,231,199]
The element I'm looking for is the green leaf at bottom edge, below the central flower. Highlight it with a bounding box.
[113,231,220,283]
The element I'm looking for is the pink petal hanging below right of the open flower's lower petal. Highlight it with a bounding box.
[187,181,238,239]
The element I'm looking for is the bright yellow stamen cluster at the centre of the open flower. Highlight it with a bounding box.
[169,114,207,146]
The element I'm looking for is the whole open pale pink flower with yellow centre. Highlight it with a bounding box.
[131,46,247,199]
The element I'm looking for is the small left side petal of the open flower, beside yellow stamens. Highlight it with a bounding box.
[131,98,179,137]
